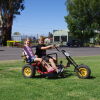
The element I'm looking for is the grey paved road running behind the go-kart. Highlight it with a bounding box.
[0,47,100,60]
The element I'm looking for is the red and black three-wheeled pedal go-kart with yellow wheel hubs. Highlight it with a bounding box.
[22,47,91,79]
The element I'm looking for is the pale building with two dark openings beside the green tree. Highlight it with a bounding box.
[53,30,69,45]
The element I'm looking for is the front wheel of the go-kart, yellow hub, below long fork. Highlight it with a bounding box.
[75,65,91,79]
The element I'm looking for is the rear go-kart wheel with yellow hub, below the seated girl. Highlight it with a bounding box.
[22,64,36,78]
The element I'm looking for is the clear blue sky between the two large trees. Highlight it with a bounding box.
[12,0,67,36]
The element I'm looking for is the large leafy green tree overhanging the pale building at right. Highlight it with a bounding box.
[65,0,100,43]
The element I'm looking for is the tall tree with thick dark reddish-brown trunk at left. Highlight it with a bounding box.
[0,0,24,45]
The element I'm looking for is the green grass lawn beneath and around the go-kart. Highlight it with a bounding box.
[0,56,100,100]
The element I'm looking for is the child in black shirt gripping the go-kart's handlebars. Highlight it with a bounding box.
[36,36,63,73]
